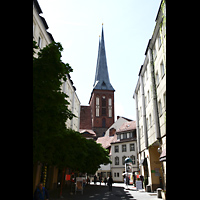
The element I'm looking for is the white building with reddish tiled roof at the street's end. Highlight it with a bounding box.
[111,121,138,182]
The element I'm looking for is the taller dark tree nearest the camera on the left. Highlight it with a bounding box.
[33,42,75,163]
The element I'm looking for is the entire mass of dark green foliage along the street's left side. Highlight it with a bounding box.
[33,42,110,174]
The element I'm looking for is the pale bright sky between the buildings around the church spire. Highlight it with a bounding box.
[38,0,161,120]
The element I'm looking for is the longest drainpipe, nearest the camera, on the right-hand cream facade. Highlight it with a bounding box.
[148,48,161,141]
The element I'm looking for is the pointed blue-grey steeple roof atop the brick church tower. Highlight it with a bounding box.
[93,24,115,91]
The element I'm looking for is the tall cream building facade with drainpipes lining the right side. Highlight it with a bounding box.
[133,1,166,191]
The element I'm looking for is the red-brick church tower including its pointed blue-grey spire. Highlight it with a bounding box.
[89,24,115,137]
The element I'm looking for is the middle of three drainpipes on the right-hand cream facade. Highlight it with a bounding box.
[140,75,148,149]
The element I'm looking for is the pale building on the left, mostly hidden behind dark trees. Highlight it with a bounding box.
[33,0,80,192]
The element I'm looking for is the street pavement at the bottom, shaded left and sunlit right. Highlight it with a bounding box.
[49,183,162,200]
